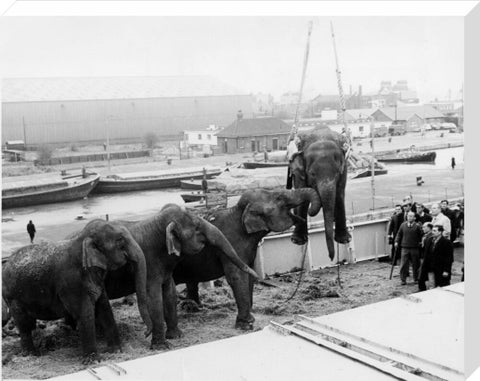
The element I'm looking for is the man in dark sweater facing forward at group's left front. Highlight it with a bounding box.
[395,211,422,285]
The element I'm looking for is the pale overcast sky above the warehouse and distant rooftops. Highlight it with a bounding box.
[0,16,464,101]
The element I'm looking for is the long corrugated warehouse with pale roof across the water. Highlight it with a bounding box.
[2,76,253,145]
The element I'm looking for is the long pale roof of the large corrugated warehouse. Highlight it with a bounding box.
[2,76,246,102]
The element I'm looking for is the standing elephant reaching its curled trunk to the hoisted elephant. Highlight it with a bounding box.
[173,188,320,330]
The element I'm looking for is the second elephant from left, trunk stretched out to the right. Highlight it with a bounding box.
[105,204,258,349]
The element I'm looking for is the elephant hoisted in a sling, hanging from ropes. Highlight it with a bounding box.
[290,129,351,260]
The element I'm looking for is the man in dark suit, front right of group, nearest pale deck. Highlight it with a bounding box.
[431,225,453,287]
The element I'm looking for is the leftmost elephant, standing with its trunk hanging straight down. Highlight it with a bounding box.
[2,219,152,364]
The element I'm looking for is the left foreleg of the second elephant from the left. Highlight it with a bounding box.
[148,277,170,350]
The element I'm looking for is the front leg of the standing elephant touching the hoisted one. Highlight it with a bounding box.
[224,262,255,330]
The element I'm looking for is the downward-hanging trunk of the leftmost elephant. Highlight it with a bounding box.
[127,238,152,336]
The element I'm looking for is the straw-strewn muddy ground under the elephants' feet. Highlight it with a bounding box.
[2,247,463,379]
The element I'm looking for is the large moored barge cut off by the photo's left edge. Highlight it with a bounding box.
[2,173,100,209]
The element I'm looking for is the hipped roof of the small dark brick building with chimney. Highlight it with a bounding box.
[217,117,291,138]
